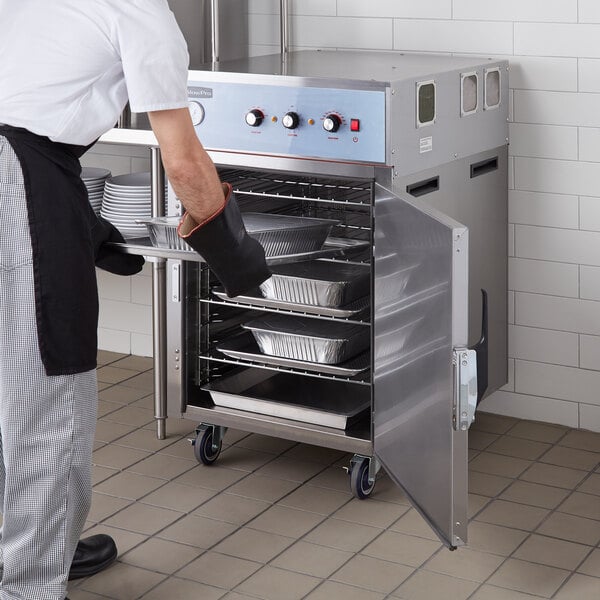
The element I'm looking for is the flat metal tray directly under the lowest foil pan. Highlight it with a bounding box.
[216,333,370,377]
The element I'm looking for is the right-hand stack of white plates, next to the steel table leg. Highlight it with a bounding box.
[100,172,166,238]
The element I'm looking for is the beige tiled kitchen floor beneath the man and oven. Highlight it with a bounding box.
[69,352,600,600]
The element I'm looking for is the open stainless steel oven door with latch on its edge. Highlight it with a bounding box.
[373,184,476,547]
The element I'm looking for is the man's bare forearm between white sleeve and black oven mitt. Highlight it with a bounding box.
[148,108,224,223]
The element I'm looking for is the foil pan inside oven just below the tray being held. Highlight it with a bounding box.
[260,260,370,308]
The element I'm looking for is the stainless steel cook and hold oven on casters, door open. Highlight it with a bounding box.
[122,51,508,547]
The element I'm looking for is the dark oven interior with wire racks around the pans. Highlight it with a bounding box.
[182,164,374,437]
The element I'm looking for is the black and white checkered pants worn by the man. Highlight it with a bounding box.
[0,136,97,600]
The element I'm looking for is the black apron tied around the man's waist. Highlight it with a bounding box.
[0,125,98,375]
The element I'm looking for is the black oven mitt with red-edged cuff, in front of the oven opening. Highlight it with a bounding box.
[177,183,271,298]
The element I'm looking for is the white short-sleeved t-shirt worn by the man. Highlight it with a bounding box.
[0,0,189,145]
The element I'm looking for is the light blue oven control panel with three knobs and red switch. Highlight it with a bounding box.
[188,81,386,164]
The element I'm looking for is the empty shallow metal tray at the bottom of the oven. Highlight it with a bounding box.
[202,369,371,429]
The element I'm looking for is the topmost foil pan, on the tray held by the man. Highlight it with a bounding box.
[242,212,339,257]
